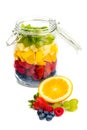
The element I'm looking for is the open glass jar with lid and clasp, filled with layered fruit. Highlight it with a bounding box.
[7,19,79,87]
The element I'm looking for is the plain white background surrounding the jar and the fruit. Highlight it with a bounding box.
[0,0,87,130]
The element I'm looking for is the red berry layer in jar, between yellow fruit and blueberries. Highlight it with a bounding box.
[14,60,56,80]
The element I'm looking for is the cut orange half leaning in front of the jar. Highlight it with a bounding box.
[38,76,73,103]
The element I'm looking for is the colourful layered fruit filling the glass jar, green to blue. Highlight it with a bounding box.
[14,23,58,86]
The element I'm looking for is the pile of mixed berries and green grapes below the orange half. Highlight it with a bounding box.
[28,93,78,121]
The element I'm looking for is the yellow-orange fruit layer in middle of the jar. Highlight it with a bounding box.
[14,43,58,65]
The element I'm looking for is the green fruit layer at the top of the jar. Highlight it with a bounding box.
[18,24,55,48]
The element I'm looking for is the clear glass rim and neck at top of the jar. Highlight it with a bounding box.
[15,18,57,35]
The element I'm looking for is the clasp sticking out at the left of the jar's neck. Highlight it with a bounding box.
[6,30,17,46]
